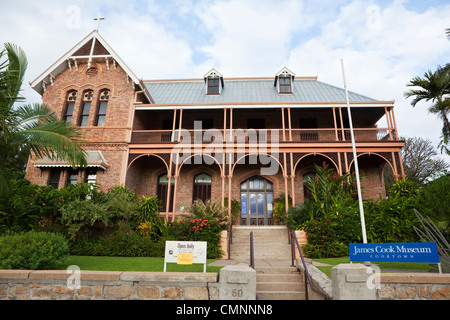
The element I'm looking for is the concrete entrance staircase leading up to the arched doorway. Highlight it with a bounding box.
[230,226,305,300]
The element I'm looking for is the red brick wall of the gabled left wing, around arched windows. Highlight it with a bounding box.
[26,63,135,190]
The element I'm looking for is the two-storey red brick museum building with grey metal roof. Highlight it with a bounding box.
[26,30,403,225]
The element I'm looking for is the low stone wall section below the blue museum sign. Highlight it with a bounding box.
[377,273,450,300]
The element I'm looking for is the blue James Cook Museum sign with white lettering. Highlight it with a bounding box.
[349,242,440,263]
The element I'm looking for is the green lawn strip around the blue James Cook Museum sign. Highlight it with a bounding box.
[313,257,437,278]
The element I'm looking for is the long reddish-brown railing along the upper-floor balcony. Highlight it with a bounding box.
[131,128,398,144]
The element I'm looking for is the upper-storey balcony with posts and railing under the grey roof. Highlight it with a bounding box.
[130,108,399,148]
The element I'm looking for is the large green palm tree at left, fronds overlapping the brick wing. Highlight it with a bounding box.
[0,43,87,191]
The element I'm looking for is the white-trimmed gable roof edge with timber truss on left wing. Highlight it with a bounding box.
[30,30,148,95]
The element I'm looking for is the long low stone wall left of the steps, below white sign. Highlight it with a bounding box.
[0,270,219,300]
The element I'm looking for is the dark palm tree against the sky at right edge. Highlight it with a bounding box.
[404,64,450,154]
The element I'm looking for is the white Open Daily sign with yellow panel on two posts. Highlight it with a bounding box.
[164,241,207,272]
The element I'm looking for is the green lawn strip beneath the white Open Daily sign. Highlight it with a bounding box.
[67,256,221,272]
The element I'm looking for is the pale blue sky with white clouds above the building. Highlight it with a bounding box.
[0,0,450,162]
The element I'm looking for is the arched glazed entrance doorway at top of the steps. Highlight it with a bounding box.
[241,176,273,226]
